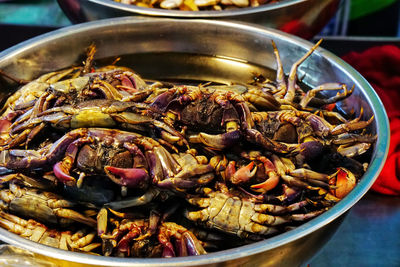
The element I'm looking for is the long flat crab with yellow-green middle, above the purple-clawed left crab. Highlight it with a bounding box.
[5,99,187,149]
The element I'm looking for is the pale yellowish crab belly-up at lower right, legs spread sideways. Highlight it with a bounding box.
[185,184,326,240]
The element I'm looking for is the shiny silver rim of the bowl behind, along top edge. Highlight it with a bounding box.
[77,0,308,18]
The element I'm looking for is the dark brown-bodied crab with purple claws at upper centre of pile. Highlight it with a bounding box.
[146,85,295,153]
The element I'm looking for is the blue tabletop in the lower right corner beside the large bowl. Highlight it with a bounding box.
[304,192,400,267]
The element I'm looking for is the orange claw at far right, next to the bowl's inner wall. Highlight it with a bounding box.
[329,167,357,199]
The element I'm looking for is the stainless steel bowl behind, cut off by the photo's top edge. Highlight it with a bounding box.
[58,0,341,39]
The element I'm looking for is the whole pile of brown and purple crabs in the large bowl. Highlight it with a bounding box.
[0,43,376,257]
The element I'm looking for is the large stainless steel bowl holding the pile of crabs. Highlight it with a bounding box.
[0,18,389,266]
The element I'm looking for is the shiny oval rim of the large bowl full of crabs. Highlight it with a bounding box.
[0,17,390,266]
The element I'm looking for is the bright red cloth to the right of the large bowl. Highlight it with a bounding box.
[342,45,400,195]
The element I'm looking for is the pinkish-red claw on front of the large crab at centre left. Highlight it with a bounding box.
[104,166,150,187]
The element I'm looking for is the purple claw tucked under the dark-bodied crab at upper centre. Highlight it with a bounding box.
[199,130,240,152]
